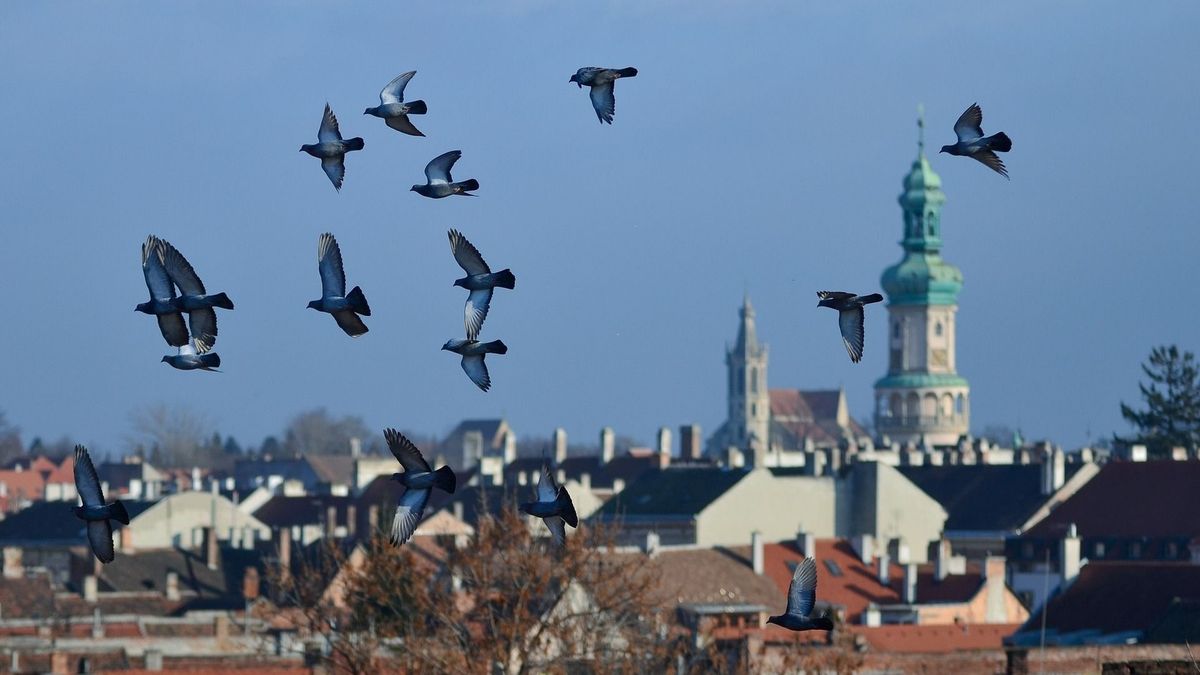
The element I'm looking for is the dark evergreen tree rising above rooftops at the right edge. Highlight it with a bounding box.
[1117,345,1200,456]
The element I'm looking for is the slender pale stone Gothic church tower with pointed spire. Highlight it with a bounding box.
[725,294,770,453]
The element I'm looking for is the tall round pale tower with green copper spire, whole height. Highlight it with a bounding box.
[875,109,971,447]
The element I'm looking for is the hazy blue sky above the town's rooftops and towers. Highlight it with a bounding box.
[0,0,1200,452]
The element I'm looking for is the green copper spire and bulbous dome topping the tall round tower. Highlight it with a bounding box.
[881,107,962,305]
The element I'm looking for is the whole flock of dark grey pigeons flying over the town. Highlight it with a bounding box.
[88,67,1013,631]
